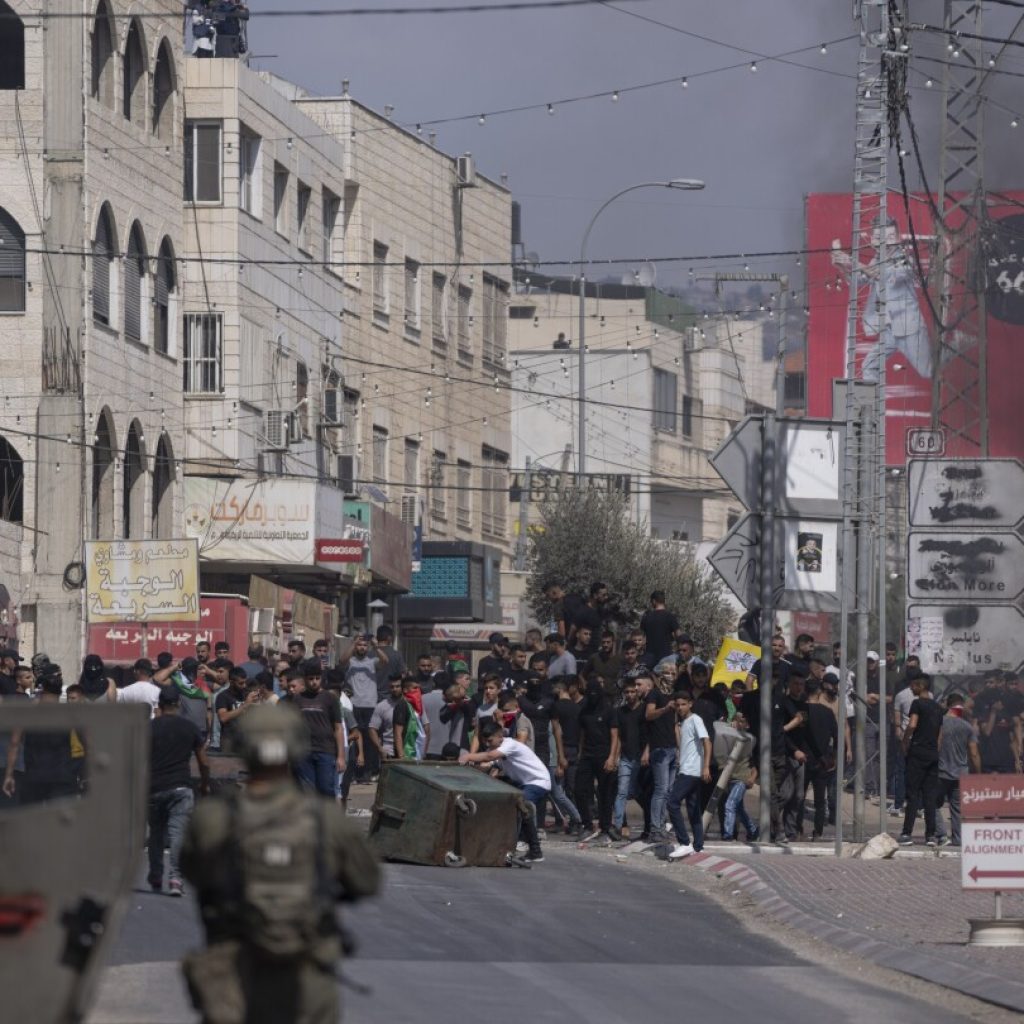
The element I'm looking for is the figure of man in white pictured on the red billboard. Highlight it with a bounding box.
[831,217,932,383]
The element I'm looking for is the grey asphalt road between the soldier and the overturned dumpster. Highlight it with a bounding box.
[88,844,978,1024]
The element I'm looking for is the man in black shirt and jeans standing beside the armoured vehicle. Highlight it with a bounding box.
[147,685,210,896]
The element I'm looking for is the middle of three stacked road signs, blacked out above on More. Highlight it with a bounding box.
[907,528,1024,601]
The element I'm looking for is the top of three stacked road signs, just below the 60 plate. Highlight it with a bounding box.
[907,459,1024,529]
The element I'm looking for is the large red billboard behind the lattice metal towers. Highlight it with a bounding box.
[807,191,1024,466]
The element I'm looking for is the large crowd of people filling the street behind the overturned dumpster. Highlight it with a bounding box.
[0,583,1024,872]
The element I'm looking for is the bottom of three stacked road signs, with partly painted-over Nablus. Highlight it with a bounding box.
[906,604,1024,675]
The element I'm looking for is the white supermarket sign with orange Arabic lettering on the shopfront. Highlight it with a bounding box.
[184,476,313,565]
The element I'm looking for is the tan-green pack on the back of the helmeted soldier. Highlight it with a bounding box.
[225,795,337,959]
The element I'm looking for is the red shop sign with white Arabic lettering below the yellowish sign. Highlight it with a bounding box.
[89,597,249,664]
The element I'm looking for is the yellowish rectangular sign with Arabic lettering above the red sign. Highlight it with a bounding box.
[85,540,199,623]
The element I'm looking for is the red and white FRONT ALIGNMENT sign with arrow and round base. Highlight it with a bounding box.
[961,775,1024,946]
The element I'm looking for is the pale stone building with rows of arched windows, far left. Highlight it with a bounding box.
[0,0,184,677]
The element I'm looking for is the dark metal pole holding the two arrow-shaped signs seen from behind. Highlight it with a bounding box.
[758,413,775,838]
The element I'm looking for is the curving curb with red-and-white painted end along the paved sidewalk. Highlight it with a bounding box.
[685,852,1024,1013]
